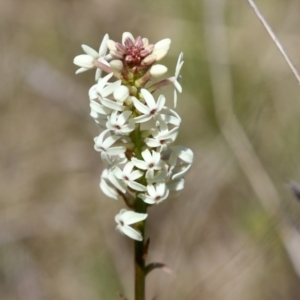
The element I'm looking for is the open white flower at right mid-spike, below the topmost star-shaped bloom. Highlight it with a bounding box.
[145,119,179,152]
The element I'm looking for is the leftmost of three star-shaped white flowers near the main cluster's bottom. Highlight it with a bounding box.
[112,161,146,192]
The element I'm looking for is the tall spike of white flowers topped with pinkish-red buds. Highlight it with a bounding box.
[74,32,193,241]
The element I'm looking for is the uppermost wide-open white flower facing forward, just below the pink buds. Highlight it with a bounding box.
[132,89,166,123]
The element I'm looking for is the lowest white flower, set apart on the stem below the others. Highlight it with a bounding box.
[115,209,148,241]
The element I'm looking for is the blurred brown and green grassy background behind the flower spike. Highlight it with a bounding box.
[0,0,300,300]
